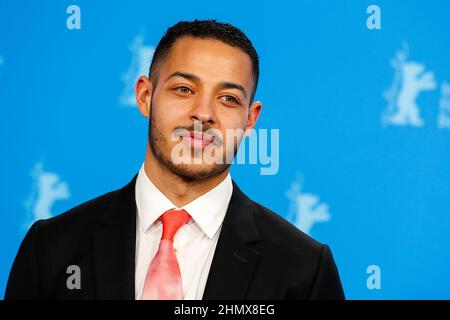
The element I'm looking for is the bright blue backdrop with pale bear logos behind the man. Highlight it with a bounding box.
[0,0,450,299]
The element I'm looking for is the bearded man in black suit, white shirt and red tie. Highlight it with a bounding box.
[6,20,344,299]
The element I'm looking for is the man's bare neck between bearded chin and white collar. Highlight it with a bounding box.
[144,146,230,208]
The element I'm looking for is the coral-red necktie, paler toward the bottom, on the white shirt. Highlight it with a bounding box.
[142,209,191,300]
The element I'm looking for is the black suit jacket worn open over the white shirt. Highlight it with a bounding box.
[5,175,344,300]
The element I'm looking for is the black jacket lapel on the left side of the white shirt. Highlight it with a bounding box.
[93,176,137,300]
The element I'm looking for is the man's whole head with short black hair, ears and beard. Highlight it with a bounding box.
[136,20,261,179]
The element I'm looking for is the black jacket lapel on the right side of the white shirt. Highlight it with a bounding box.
[203,181,261,300]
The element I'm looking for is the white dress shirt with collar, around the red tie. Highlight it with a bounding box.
[135,165,233,300]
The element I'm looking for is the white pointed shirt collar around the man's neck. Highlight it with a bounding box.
[136,165,233,239]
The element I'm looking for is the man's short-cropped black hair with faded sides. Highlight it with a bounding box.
[149,19,259,103]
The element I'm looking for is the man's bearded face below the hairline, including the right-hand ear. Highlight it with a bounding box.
[139,37,261,179]
